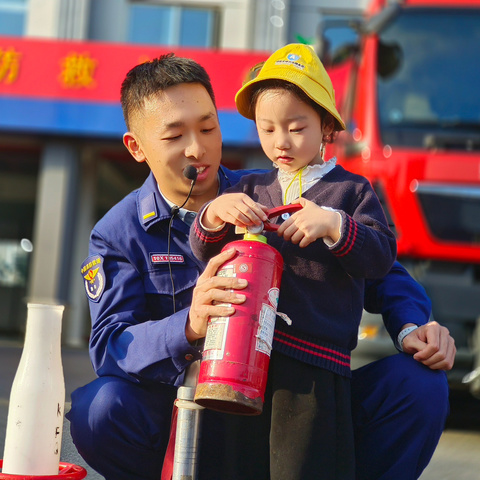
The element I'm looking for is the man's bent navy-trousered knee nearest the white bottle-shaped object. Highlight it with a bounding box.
[67,377,176,480]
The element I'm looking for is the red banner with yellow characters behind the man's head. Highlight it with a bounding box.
[0,36,268,109]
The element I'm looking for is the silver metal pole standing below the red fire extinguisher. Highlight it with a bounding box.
[172,360,204,480]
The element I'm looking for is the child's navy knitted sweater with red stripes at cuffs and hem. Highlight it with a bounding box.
[190,165,396,376]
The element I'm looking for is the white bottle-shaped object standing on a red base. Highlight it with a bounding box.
[2,303,65,475]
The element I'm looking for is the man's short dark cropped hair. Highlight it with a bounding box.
[120,53,215,128]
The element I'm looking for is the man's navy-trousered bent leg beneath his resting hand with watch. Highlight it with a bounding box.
[352,354,449,479]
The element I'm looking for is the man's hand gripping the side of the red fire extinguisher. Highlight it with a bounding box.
[185,248,248,343]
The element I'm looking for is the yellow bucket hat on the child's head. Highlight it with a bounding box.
[235,43,345,131]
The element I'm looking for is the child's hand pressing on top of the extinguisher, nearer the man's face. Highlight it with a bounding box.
[202,193,268,228]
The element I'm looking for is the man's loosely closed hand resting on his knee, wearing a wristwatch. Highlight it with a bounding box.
[403,322,457,370]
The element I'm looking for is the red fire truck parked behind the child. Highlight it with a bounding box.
[319,0,480,396]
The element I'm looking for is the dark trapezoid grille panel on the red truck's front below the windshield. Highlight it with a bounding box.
[416,184,480,245]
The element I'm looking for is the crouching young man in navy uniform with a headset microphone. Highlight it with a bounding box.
[68,55,455,480]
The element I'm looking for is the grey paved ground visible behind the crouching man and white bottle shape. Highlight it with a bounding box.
[0,340,480,480]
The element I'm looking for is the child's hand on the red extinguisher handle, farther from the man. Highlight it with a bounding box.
[277,198,341,248]
